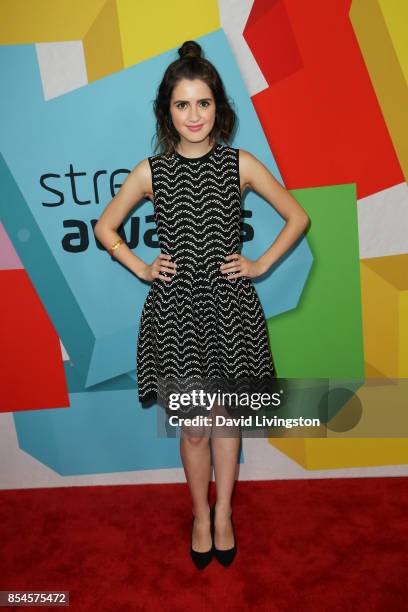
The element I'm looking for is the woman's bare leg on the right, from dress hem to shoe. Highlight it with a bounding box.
[211,405,241,550]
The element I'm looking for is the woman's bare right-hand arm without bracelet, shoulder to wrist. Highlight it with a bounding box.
[239,149,309,274]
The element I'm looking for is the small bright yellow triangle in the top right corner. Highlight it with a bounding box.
[379,0,408,81]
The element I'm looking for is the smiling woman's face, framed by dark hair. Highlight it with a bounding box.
[170,79,215,143]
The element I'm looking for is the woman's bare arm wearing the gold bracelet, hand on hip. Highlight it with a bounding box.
[94,159,175,281]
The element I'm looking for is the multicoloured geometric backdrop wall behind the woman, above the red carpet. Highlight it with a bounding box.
[0,0,408,488]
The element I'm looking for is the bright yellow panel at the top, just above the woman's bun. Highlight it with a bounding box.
[117,0,221,67]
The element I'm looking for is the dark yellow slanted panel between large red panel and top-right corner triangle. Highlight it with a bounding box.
[350,0,408,178]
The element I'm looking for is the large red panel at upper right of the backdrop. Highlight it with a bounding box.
[244,0,404,198]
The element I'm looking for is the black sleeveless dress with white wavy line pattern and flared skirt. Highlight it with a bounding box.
[137,143,275,409]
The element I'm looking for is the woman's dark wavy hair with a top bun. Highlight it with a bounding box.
[153,40,237,155]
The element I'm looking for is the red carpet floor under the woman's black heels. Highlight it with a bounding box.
[0,477,408,612]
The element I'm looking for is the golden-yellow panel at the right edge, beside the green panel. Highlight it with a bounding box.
[361,254,408,378]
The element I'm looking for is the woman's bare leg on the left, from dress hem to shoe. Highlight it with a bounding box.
[180,425,211,552]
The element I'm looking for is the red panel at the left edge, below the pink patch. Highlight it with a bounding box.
[0,270,69,412]
